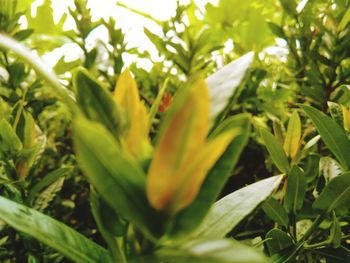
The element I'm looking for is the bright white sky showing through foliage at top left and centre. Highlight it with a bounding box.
[34,0,218,68]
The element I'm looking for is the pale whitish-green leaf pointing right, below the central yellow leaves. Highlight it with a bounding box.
[191,176,282,238]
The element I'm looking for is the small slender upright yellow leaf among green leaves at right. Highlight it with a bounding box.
[283,111,301,159]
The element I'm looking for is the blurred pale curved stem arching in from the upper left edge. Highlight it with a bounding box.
[0,33,78,113]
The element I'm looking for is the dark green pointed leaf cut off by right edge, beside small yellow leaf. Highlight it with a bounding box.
[300,105,350,170]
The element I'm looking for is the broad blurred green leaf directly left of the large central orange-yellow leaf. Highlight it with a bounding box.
[74,117,162,237]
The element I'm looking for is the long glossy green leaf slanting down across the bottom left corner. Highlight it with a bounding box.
[0,196,111,263]
